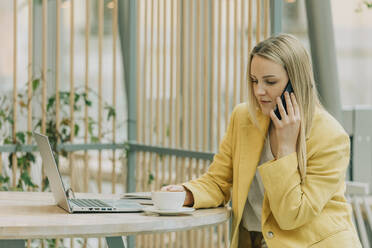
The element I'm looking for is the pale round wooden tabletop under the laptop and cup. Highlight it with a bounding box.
[0,192,231,239]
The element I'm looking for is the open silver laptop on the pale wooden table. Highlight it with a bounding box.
[33,132,143,213]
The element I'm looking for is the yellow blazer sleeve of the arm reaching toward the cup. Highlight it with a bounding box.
[183,108,237,208]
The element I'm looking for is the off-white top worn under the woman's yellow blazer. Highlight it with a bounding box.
[242,135,274,232]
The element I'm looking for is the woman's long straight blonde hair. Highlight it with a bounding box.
[247,34,322,183]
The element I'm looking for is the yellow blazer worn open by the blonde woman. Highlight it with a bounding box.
[184,103,361,248]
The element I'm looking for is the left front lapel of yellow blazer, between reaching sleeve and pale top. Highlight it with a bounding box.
[237,113,270,221]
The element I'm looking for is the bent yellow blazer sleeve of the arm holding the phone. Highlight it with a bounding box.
[258,123,350,230]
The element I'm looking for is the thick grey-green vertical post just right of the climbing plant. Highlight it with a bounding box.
[118,0,139,248]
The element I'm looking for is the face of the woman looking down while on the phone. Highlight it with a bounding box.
[250,55,288,116]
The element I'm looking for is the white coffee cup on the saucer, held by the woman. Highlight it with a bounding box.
[151,191,186,210]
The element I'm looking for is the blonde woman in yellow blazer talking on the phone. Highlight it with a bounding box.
[162,34,361,248]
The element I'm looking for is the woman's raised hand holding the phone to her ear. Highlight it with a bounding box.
[270,92,301,159]
